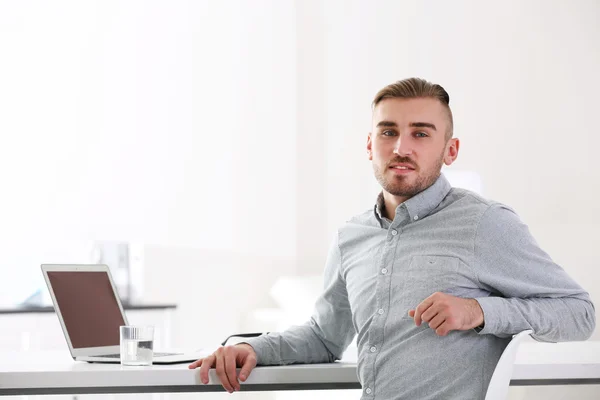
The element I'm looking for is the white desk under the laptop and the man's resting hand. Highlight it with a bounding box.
[0,342,600,395]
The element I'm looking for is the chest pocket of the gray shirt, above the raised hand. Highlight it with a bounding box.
[396,256,459,318]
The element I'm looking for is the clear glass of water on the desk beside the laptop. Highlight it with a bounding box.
[120,326,154,365]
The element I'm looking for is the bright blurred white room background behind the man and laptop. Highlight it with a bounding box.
[0,0,600,399]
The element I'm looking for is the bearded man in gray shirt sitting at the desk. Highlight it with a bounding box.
[190,78,595,400]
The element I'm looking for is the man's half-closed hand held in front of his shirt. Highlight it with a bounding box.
[408,292,483,336]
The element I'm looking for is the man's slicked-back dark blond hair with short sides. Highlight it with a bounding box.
[373,78,454,140]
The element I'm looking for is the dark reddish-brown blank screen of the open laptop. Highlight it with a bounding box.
[48,271,125,349]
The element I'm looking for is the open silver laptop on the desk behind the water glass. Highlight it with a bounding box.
[42,264,210,364]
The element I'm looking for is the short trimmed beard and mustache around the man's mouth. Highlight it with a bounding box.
[373,153,444,199]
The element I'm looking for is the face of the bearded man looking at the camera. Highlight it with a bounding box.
[367,98,459,201]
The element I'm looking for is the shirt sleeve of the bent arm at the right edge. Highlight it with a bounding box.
[474,204,596,342]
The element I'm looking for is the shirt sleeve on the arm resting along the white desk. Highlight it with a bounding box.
[244,231,356,365]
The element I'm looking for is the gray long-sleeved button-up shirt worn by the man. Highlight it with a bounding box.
[247,175,595,400]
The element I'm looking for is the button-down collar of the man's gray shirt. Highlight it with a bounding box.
[374,174,452,222]
